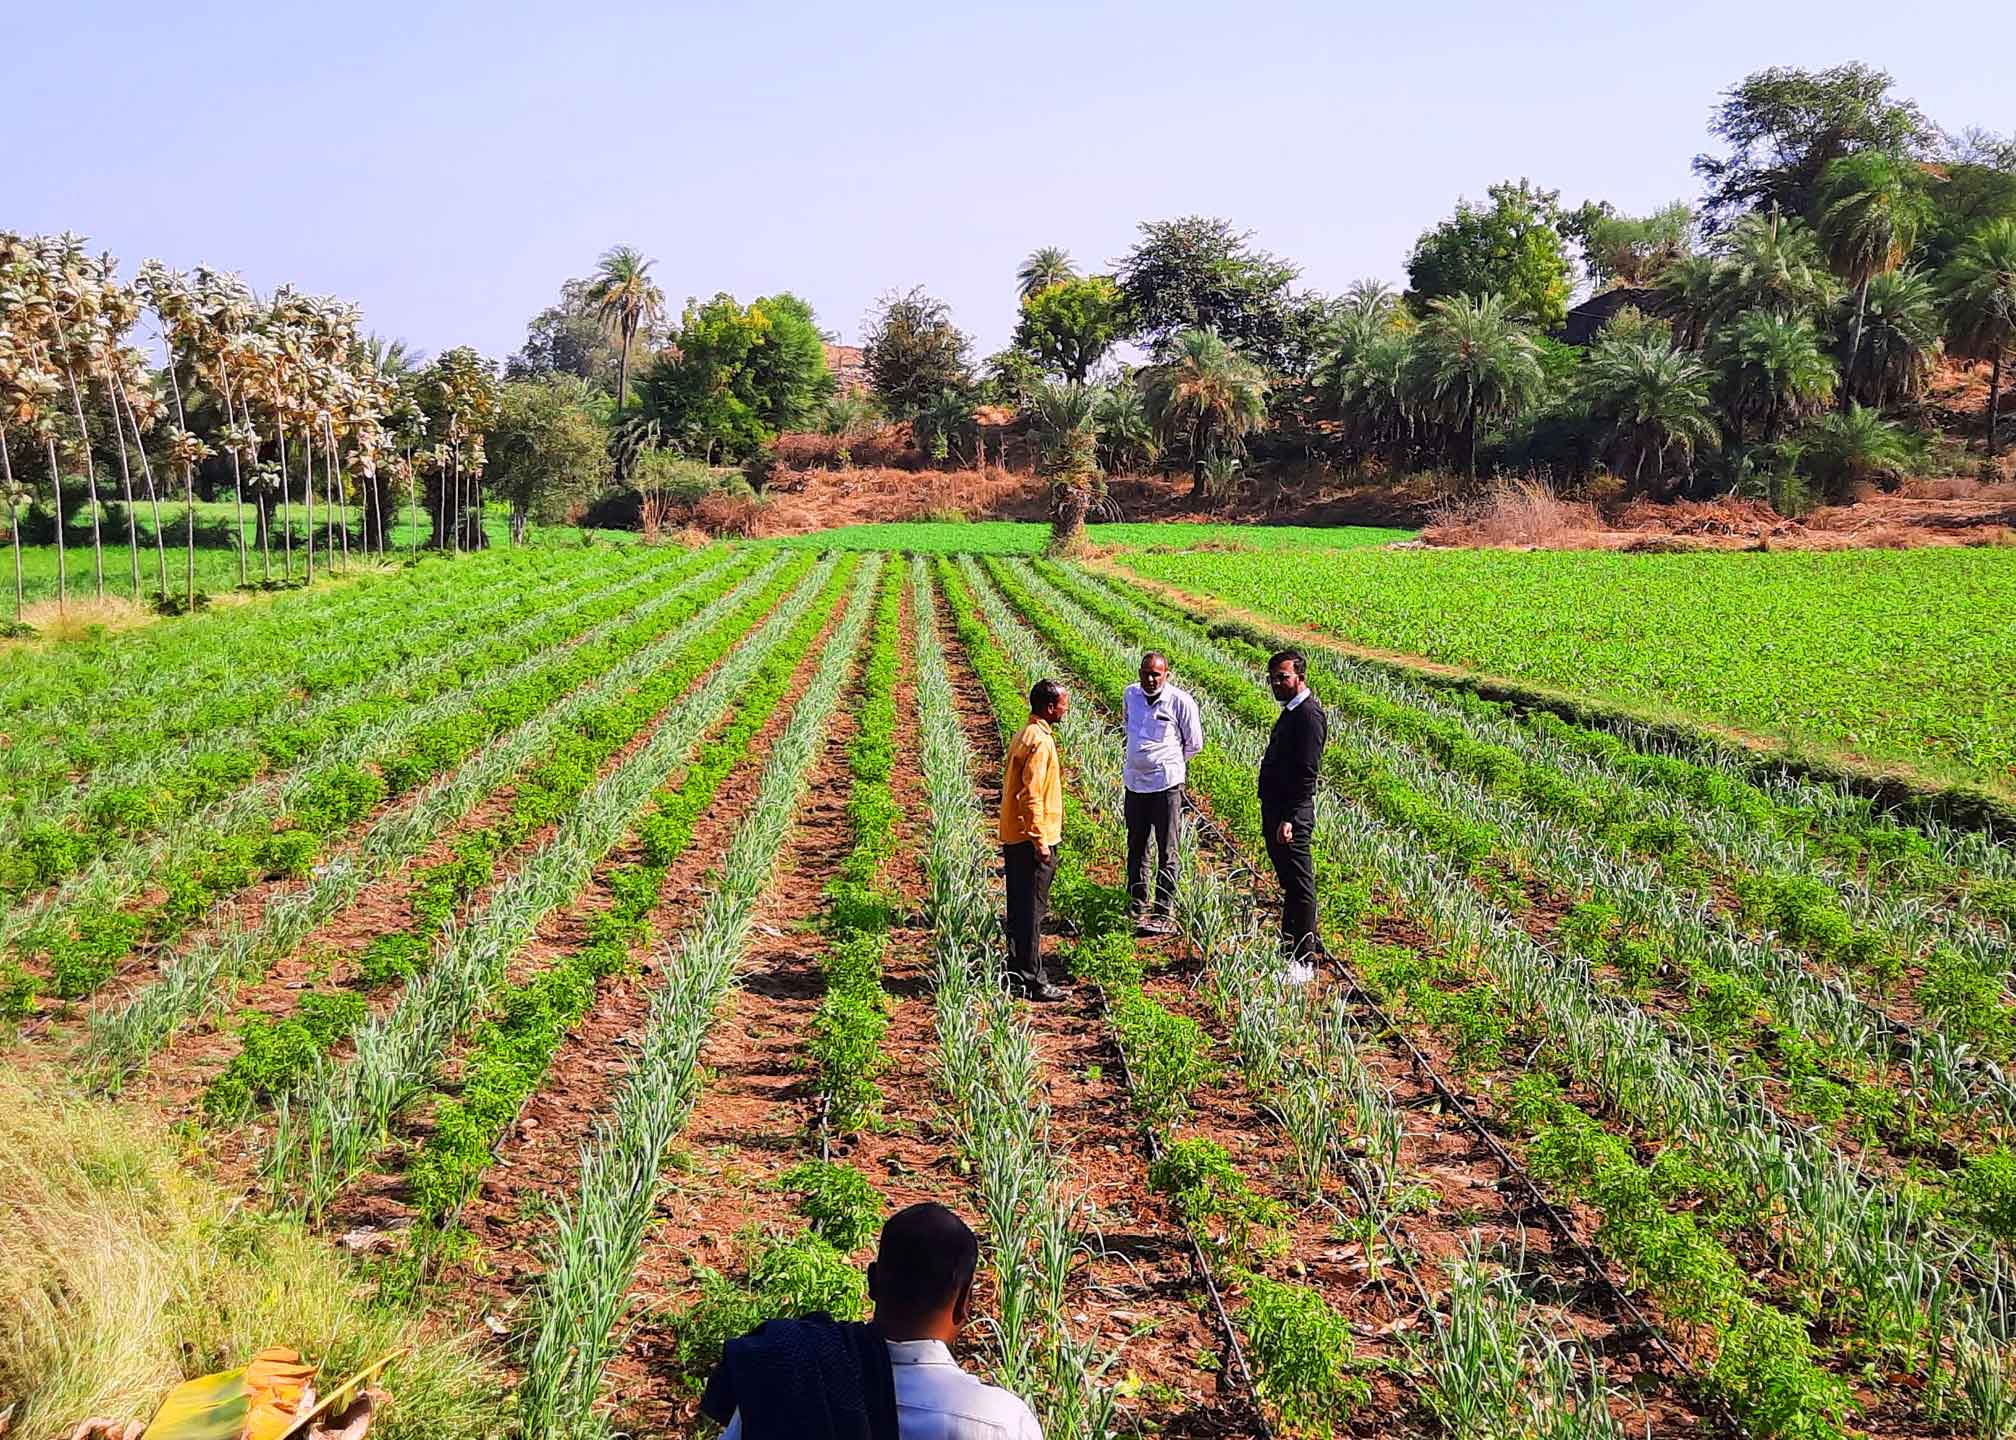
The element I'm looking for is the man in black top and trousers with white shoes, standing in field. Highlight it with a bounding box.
[1260,649,1331,984]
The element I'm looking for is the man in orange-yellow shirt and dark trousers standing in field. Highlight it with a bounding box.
[1000,680,1070,1000]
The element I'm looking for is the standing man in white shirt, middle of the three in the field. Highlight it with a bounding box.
[1121,649,1204,934]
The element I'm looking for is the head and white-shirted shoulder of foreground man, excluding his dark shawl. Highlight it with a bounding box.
[722,1204,1042,1440]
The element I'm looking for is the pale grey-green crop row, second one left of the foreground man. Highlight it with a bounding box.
[268,561,835,1210]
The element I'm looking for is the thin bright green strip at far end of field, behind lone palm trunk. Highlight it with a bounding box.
[772,520,1413,555]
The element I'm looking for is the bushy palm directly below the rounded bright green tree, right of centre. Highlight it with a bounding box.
[1409,294,1546,480]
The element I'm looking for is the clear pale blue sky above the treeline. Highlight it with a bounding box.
[15,0,2016,359]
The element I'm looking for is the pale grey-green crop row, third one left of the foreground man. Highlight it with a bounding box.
[87,548,792,1081]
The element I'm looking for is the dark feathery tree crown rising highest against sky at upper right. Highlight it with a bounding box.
[1693,65,1937,230]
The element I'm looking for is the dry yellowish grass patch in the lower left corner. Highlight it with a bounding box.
[0,1067,504,1440]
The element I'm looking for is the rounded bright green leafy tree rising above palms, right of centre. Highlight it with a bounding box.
[1407,179,1574,325]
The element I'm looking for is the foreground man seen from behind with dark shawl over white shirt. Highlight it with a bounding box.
[700,1202,1042,1440]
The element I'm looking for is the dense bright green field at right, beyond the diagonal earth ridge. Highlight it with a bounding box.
[1127,549,2016,785]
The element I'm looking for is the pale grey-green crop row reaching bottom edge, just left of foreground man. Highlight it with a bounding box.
[518,561,881,1440]
